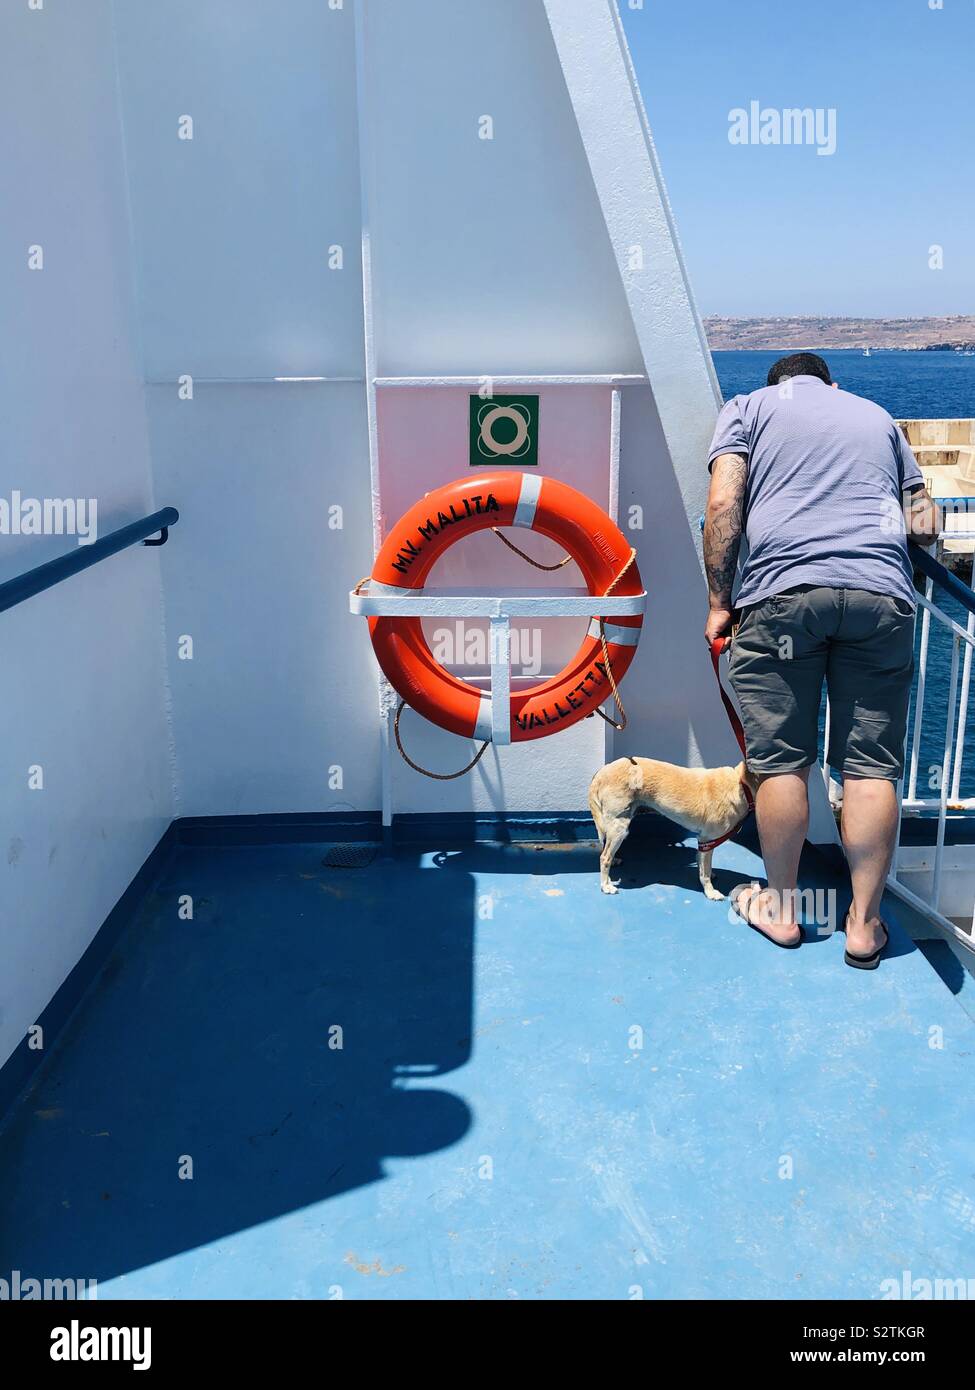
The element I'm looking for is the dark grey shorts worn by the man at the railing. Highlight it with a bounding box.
[729,584,914,781]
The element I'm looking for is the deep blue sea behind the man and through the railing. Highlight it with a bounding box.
[712,349,975,796]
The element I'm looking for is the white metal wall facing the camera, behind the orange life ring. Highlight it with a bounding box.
[115,0,714,815]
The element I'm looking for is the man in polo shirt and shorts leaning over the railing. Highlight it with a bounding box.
[704,353,942,969]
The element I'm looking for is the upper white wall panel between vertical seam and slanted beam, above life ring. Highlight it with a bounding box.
[363,0,643,377]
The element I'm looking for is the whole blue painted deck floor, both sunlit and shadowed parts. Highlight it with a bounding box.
[0,822,975,1298]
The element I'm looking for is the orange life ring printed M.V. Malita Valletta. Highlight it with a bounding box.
[369,471,643,744]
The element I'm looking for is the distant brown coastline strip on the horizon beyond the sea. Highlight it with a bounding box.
[704,314,975,352]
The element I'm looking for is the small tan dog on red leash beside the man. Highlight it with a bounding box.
[590,758,757,901]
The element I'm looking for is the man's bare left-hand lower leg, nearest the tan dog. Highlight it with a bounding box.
[748,767,809,944]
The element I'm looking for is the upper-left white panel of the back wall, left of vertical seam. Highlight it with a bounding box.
[114,0,363,380]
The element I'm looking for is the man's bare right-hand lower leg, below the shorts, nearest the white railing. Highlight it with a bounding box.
[843,776,897,955]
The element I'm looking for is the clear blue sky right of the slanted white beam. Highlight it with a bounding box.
[619,0,975,317]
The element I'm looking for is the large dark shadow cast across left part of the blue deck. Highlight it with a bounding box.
[0,845,476,1297]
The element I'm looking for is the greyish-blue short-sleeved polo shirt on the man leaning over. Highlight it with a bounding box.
[708,377,924,606]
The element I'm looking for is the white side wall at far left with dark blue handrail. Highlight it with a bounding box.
[0,0,172,1062]
